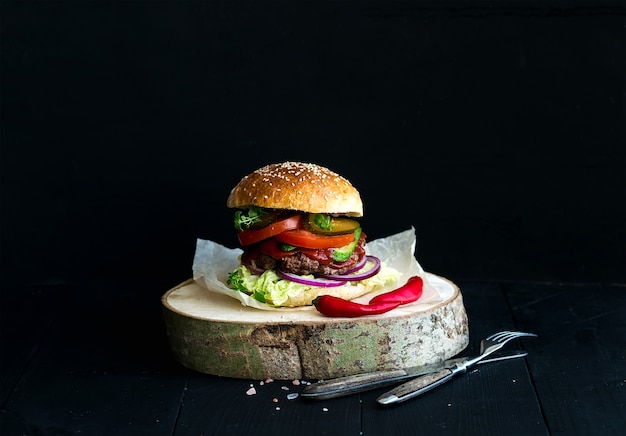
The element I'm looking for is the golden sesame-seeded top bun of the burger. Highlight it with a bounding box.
[226,162,363,217]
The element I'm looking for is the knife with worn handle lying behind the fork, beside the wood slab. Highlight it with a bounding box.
[300,351,528,400]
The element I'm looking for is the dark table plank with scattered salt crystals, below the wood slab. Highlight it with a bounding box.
[176,375,361,435]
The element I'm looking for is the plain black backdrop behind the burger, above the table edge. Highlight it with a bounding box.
[1,1,626,292]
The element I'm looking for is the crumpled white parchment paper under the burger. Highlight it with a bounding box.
[193,227,444,311]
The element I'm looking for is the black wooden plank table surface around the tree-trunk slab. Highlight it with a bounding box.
[0,282,626,435]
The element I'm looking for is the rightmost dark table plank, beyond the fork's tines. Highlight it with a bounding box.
[507,284,626,435]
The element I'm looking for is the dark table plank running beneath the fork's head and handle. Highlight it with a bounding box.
[363,284,547,435]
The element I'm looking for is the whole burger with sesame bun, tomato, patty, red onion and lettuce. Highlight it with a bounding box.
[227,162,399,307]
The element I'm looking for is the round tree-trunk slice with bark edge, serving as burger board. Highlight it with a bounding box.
[162,274,469,380]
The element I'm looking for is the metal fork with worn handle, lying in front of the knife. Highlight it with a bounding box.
[376,331,537,405]
